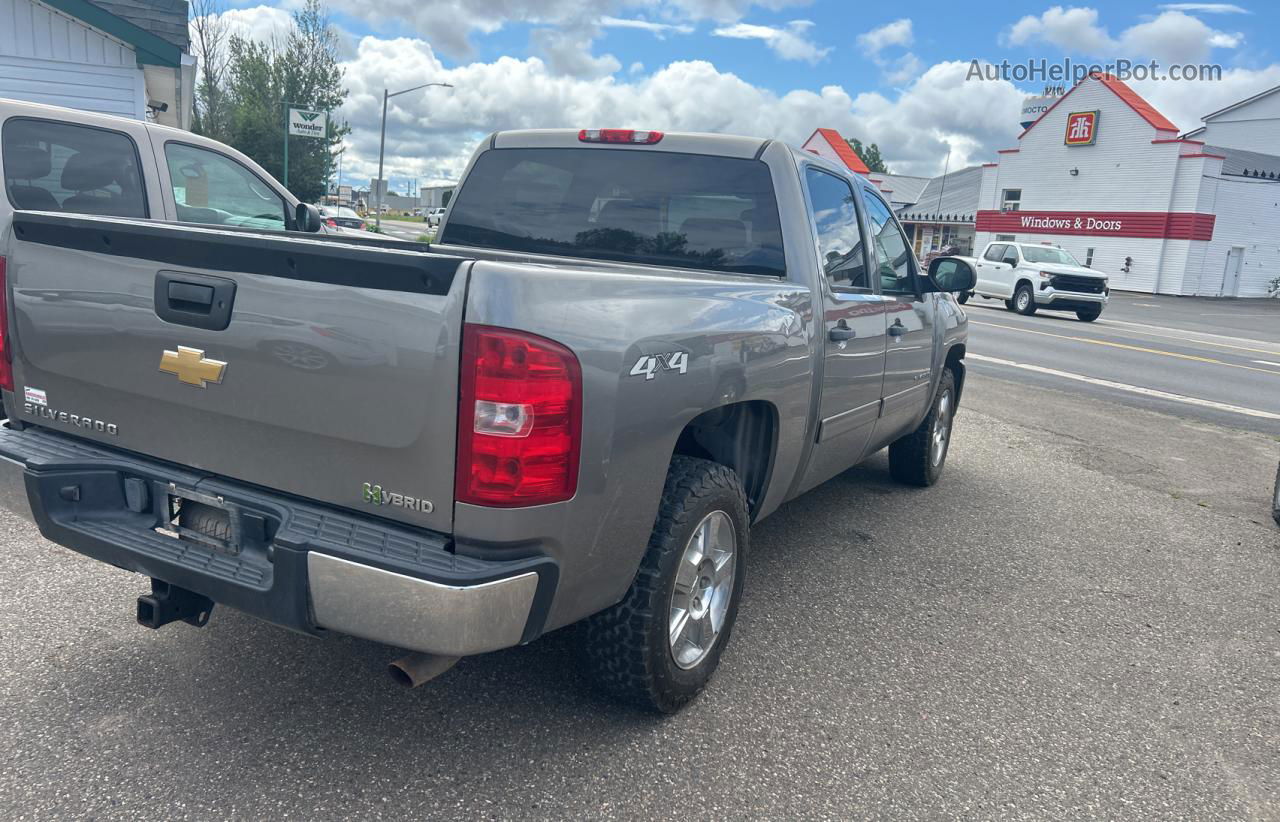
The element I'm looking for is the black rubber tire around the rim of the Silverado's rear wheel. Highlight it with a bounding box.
[585,457,749,713]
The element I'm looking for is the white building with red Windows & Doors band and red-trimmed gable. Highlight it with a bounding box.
[974,76,1280,297]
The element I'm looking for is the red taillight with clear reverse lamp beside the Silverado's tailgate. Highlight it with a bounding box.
[454,324,582,508]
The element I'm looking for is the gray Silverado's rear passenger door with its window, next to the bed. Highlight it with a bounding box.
[804,166,886,488]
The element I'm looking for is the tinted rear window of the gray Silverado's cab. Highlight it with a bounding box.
[440,149,786,277]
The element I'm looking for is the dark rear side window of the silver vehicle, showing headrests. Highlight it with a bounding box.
[0,118,147,218]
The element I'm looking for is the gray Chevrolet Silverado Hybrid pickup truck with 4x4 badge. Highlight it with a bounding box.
[0,123,974,712]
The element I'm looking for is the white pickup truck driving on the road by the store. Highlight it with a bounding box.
[973,242,1111,323]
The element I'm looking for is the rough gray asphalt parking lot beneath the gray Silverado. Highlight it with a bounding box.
[0,297,1280,819]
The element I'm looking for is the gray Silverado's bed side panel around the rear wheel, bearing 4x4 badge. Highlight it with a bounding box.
[454,261,812,630]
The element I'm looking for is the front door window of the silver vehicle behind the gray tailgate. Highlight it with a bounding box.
[164,142,287,230]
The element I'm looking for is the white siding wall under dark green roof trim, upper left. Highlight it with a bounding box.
[0,0,146,119]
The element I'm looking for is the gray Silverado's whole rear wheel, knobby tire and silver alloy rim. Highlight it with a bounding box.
[586,457,749,713]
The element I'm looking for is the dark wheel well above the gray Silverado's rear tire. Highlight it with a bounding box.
[672,399,778,520]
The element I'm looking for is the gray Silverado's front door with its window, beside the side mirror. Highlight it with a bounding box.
[863,188,934,443]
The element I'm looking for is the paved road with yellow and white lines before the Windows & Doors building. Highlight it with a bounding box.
[968,294,1280,435]
